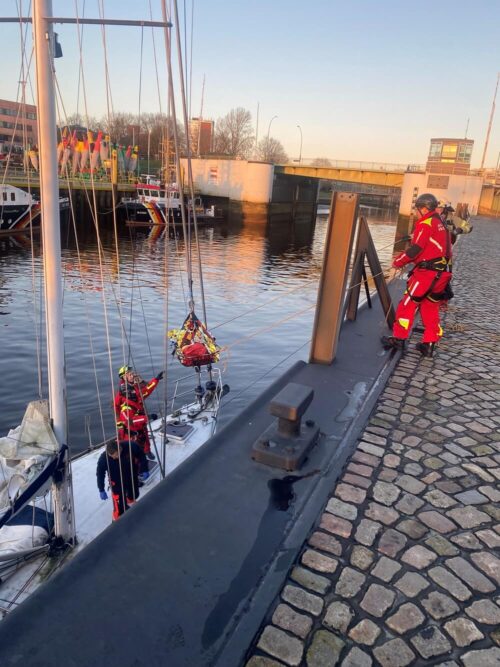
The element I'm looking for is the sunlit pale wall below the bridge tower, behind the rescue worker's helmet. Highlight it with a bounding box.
[399,172,483,215]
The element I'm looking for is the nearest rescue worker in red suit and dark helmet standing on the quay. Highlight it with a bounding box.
[382,193,451,357]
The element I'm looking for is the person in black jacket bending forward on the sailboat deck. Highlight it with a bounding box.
[96,440,149,521]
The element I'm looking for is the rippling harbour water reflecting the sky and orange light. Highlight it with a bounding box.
[0,209,397,453]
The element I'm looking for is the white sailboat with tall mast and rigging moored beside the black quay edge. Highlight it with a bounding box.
[0,0,228,615]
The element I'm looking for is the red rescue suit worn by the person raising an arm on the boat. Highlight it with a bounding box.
[114,378,159,454]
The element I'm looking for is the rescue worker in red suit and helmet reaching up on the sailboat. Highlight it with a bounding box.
[114,366,163,461]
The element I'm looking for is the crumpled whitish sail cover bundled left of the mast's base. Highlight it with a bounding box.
[0,401,59,517]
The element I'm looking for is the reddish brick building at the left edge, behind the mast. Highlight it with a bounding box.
[0,100,38,153]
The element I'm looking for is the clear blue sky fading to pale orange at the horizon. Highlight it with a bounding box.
[0,0,500,167]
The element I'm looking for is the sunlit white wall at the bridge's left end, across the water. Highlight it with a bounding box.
[181,158,274,204]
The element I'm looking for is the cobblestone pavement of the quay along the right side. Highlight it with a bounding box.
[246,219,500,667]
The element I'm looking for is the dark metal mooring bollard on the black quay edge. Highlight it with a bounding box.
[252,382,319,470]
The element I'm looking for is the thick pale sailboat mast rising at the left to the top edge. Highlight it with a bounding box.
[33,0,74,542]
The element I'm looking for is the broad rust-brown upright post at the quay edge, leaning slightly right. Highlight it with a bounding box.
[309,192,358,364]
